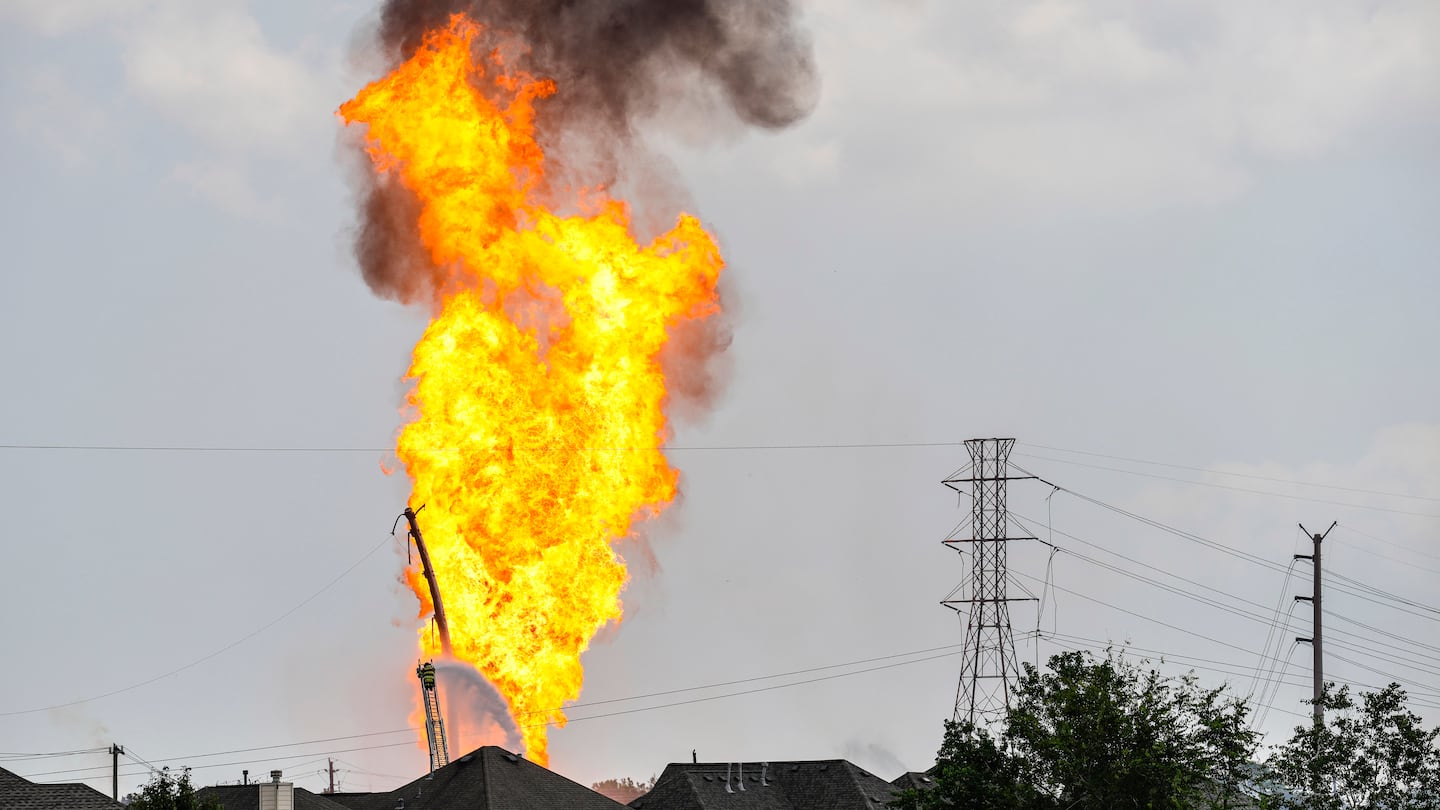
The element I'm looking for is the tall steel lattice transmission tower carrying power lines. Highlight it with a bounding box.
[940,438,1035,726]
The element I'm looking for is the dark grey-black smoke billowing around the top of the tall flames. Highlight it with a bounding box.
[345,0,818,303]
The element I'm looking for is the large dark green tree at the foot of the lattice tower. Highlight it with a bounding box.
[899,651,1259,810]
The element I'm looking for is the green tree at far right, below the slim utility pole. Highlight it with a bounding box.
[1267,683,1440,810]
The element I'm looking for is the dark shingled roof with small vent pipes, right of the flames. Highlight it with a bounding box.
[629,760,899,810]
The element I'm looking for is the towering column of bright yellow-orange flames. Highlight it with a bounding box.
[340,16,724,764]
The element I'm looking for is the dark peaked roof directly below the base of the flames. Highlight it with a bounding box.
[325,745,625,810]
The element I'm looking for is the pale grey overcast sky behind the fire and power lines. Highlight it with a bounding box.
[0,0,1440,791]
